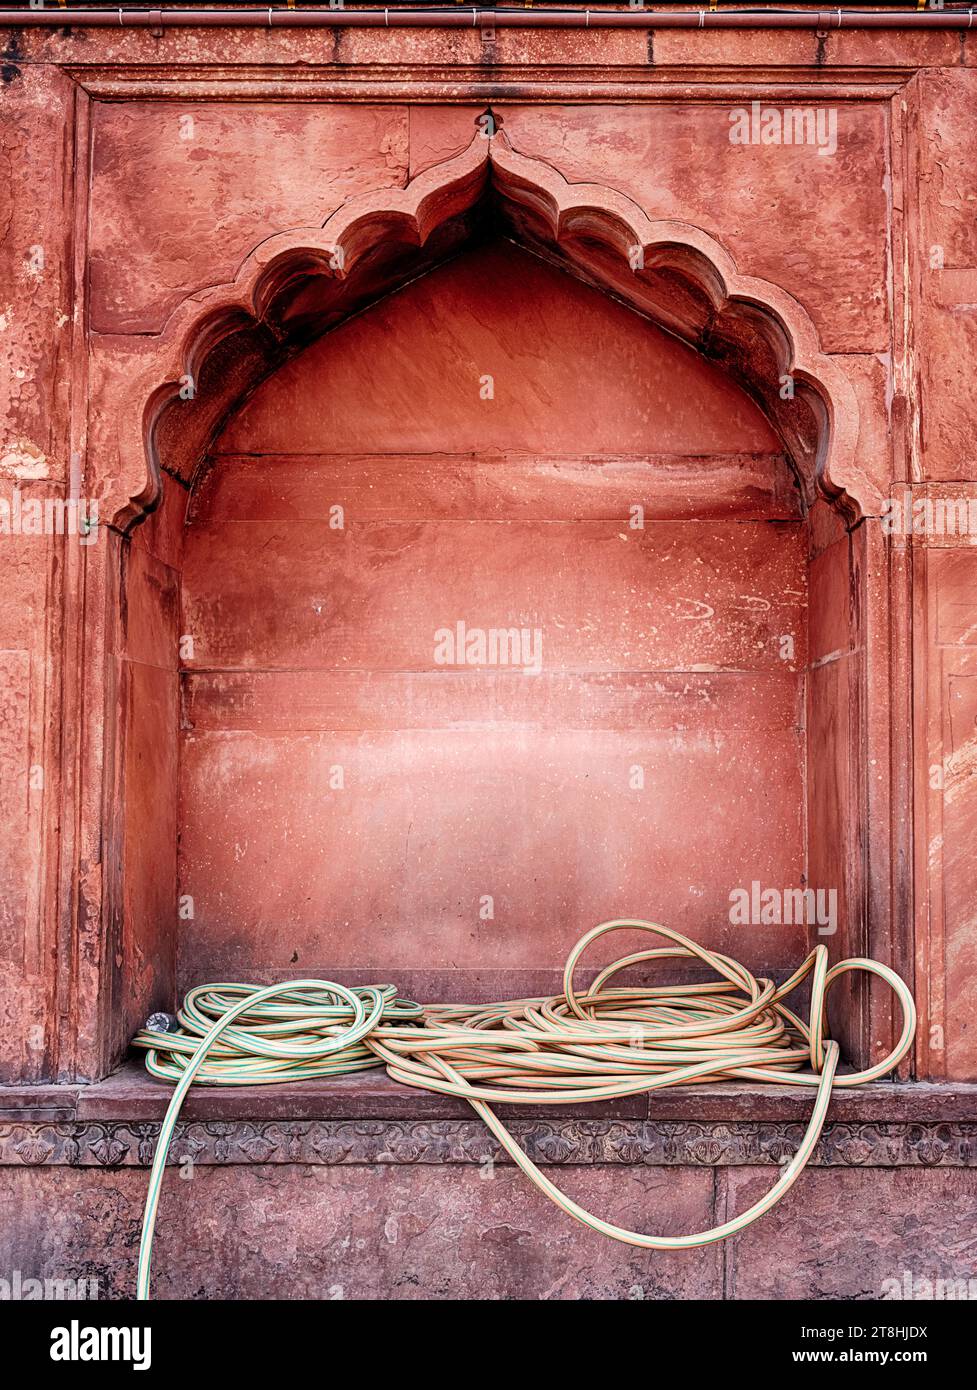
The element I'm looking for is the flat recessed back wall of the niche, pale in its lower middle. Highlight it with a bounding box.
[179,243,807,998]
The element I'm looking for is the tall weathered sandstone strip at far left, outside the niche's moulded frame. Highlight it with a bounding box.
[0,59,76,1080]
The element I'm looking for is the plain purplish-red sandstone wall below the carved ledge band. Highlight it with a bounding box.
[7,1165,977,1302]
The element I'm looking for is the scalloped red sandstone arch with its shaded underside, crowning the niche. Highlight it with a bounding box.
[111,131,881,530]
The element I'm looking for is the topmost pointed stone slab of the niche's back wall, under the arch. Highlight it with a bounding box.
[214,242,780,460]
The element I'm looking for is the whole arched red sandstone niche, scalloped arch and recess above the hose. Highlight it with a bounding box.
[107,136,877,1073]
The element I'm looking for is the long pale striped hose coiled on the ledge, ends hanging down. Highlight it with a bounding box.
[133,919,916,1300]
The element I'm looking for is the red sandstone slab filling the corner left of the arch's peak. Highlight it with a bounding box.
[90,103,407,334]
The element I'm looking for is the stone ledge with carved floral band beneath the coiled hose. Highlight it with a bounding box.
[0,1062,977,1168]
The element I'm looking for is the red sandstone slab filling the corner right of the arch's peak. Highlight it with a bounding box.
[502,103,888,352]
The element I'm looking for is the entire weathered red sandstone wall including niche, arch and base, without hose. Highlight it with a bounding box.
[0,10,977,1297]
